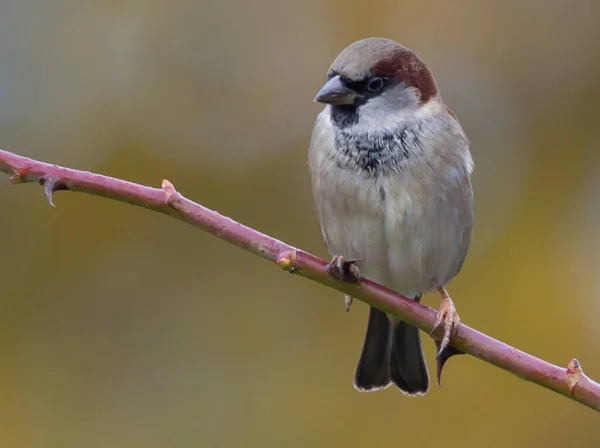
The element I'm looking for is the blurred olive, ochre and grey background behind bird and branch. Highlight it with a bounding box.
[0,0,600,448]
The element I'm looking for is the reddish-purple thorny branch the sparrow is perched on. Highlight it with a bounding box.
[0,150,600,411]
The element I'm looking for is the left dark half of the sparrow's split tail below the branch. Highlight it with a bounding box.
[354,307,392,392]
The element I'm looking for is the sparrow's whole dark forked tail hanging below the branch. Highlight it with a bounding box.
[354,299,429,395]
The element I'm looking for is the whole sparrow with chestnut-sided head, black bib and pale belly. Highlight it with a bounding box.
[309,38,473,396]
